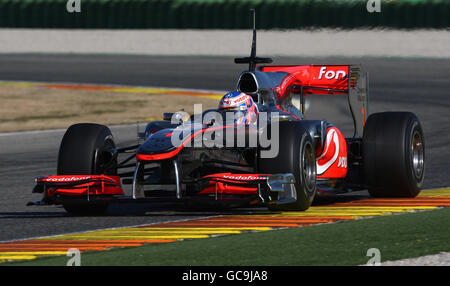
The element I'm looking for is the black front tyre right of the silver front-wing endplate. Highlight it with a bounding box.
[258,121,317,211]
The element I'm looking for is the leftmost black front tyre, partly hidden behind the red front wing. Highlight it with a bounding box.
[57,123,117,215]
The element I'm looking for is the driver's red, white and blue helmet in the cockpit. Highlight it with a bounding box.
[219,91,258,125]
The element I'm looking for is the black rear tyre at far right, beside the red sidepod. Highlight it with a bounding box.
[363,112,425,197]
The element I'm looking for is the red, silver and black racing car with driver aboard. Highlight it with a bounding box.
[29,11,425,215]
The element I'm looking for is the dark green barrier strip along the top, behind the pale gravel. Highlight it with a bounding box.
[0,0,450,29]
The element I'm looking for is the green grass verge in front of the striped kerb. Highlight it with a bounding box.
[2,208,450,266]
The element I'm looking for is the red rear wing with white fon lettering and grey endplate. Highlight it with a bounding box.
[259,65,369,138]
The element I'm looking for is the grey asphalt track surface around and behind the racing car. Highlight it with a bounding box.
[0,54,450,241]
